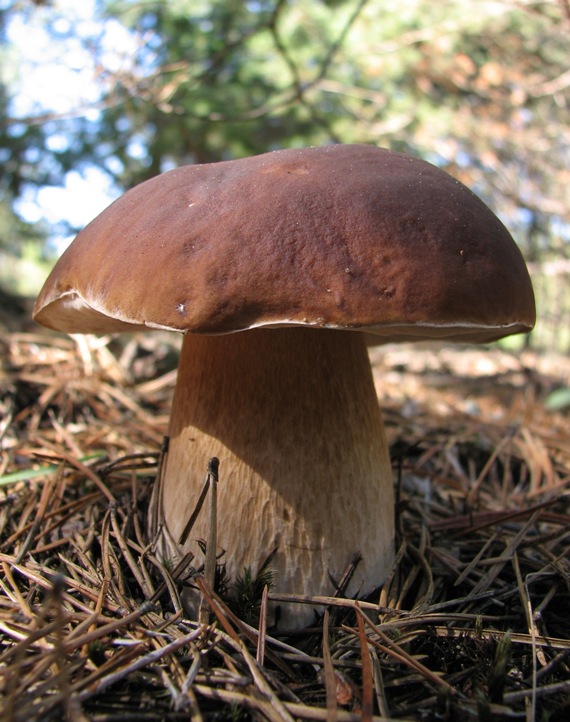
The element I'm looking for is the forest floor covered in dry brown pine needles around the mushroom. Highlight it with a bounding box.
[0,308,570,722]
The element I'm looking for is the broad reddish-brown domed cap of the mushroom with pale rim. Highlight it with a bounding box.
[34,145,535,342]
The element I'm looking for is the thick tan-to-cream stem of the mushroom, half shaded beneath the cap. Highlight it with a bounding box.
[159,328,394,626]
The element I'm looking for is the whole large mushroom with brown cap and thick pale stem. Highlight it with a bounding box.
[34,145,535,626]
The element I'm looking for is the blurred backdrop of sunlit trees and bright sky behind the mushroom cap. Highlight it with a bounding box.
[0,0,570,353]
